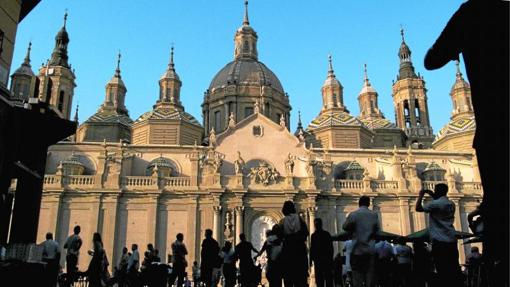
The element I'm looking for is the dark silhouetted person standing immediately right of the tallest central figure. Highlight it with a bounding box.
[310,218,333,287]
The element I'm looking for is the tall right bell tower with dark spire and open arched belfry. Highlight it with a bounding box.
[392,29,434,148]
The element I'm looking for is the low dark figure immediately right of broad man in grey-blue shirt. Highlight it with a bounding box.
[375,240,396,287]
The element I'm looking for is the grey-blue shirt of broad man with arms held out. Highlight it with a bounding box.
[343,206,381,255]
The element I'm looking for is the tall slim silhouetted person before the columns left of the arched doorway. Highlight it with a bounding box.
[200,229,221,287]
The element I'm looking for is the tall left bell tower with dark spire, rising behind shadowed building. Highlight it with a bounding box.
[35,12,76,119]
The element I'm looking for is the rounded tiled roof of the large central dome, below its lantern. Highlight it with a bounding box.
[209,58,284,94]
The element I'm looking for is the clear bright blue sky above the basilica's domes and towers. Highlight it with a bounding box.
[11,0,465,133]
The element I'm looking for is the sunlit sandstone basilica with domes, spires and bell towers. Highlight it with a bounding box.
[11,3,483,269]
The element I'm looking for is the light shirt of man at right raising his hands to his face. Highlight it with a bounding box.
[423,196,457,242]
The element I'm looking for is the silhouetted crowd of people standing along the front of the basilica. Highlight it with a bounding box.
[34,184,483,287]
